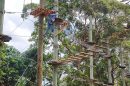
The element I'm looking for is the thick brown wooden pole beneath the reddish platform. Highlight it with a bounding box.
[37,0,45,86]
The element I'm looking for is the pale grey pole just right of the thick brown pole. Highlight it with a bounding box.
[53,0,58,86]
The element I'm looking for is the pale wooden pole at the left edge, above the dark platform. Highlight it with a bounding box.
[0,0,5,34]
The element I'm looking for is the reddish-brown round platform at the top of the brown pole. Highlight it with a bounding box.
[30,7,56,17]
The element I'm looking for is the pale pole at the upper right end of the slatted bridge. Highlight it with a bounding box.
[89,16,94,86]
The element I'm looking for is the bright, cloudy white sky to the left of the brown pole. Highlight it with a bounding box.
[3,0,39,52]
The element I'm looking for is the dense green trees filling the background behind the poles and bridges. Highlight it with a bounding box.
[0,0,130,86]
